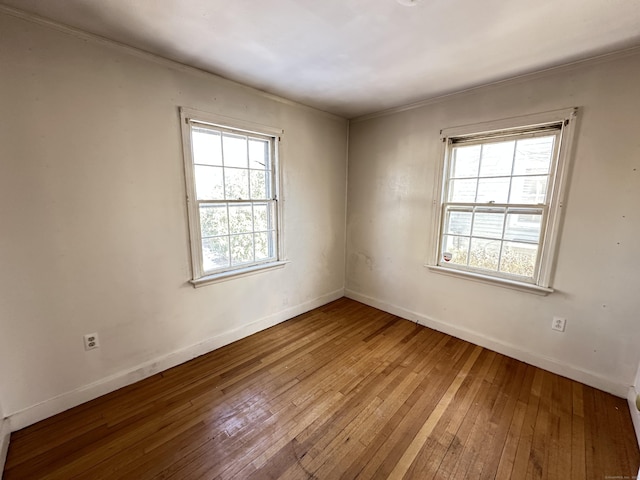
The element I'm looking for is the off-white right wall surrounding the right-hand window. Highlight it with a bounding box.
[346,50,640,397]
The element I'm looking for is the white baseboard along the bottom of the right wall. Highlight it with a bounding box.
[345,289,629,398]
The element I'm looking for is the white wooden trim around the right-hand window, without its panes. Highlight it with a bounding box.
[425,107,578,295]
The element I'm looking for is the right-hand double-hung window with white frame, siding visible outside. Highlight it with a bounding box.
[432,109,575,293]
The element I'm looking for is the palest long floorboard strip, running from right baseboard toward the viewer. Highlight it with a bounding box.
[387,347,482,480]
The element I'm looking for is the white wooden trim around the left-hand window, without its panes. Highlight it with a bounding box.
[180,107,289,288]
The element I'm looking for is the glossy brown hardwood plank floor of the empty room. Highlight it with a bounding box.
[4,298,640,480]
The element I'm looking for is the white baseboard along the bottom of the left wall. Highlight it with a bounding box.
[9,289,344,431]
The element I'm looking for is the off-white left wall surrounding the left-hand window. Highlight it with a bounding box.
[0,9,347,429]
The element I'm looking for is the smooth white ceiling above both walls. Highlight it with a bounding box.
[0,0,640,118]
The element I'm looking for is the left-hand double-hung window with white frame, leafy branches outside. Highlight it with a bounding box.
[181,109,282,286]
